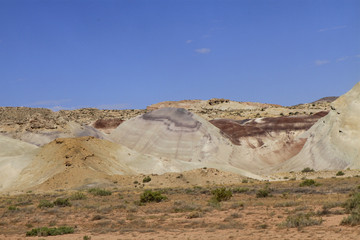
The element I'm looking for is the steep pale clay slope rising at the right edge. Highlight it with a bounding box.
[278,82,360,171]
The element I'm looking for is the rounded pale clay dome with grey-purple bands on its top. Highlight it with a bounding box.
[110,108,259,178]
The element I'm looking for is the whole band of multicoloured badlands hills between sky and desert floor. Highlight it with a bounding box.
[0,83,360,192]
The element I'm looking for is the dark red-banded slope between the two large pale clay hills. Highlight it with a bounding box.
[210,112,327,173]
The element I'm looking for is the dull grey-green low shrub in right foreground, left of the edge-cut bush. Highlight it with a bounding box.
[281,213,323,228]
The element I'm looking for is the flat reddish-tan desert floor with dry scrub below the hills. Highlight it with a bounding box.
[0,175,360,240]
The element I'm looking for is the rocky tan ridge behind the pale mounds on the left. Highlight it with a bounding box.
[0,107,145,146]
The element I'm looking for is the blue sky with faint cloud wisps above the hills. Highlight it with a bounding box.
[0,0,360,110]
